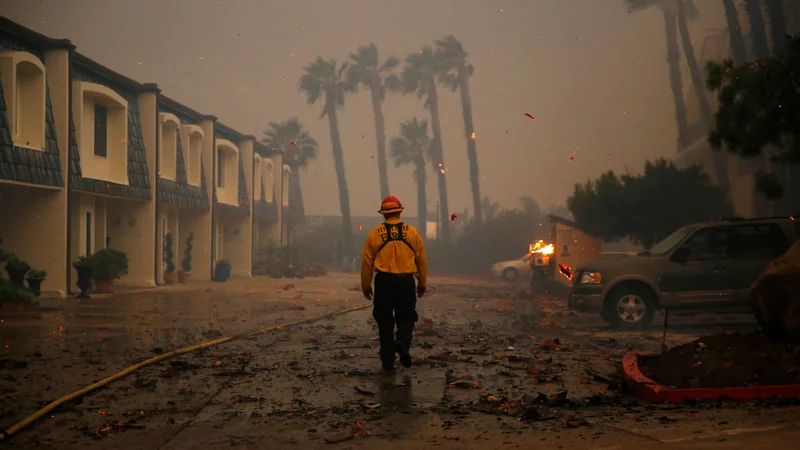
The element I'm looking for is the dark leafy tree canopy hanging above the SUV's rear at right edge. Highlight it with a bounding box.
[706,34,800,199]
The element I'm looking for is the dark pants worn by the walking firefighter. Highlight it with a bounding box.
[372,272,419,363]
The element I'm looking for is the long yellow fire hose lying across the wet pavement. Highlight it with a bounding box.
[0,304,372,442]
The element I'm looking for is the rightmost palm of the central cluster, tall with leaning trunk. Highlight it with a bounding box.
[436,35,483,224]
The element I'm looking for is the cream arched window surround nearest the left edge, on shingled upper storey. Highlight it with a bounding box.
[0,52,47,150]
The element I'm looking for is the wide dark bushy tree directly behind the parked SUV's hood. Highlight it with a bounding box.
[567,158,733,248]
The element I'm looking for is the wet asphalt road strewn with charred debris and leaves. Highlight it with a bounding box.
[0,274,800,449]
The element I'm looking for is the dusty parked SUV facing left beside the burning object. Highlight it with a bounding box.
[569,217,800,327]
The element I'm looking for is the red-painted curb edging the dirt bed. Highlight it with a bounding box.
[622,351,800,402]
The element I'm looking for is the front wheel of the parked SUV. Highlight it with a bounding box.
[601,286,656,328]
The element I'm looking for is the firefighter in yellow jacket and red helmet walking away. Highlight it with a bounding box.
[361,195,428,372]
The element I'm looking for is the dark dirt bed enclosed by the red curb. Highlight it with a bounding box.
[639,333,800,388]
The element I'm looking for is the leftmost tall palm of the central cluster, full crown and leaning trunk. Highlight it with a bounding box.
[298,57,353,255]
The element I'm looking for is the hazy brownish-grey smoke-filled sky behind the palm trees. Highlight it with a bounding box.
[0,0,724,215]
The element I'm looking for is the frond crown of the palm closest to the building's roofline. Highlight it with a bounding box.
[261,117,319,168]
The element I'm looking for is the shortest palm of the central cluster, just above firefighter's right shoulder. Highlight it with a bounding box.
[389,117,431,236]
